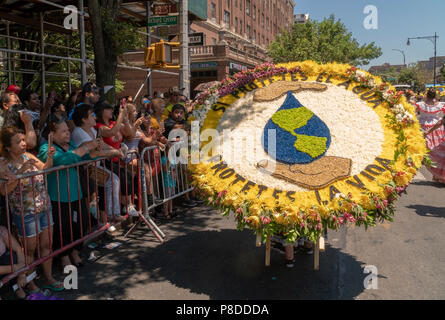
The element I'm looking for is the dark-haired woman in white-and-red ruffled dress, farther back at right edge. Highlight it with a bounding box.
[416,89,445,150]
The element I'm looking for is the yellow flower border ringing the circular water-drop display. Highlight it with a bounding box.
[190,61,427,241]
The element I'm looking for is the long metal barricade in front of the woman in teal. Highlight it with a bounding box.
[0,151,142,288]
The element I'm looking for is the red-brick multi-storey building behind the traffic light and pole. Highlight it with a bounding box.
[118,0,295,98]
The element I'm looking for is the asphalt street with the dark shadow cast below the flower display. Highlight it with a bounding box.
[31,168,445,300]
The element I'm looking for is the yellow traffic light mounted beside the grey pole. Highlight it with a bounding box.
[145,40,180,69]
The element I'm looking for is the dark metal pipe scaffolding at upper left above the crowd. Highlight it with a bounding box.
[0,0,181,104]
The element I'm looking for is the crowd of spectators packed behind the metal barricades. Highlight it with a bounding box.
[0,82,202,299]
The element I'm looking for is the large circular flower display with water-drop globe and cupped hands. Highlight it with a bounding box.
[190,61,426,241]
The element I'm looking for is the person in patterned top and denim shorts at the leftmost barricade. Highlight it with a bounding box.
[0,127,64,292]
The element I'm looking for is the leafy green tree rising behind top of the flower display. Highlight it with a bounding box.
[268,15,382,66]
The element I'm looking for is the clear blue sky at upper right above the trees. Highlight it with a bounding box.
[294,0,445,69]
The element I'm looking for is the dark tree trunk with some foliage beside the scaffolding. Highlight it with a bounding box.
[88,0,142,102]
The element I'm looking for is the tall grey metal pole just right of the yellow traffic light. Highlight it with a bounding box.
[179,0,190,98]
